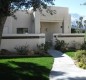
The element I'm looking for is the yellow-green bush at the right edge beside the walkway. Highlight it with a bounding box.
[75,50,86,69]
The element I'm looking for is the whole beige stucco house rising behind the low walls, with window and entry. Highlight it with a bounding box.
[3,7,71,41]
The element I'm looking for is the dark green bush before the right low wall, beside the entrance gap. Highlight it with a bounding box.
[55,39,68,51]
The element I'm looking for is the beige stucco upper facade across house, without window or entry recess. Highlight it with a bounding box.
[3,6,71,34]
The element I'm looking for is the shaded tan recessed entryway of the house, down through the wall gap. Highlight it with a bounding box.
[40,22,62,41]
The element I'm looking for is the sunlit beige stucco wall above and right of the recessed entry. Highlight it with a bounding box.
[38,6,71,33]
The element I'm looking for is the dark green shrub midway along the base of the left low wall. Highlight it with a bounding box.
[15,45,29,55]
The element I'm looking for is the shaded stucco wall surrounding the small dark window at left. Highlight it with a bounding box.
[3,11,35,34]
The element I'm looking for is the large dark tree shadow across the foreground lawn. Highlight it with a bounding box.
[0,61,50,80]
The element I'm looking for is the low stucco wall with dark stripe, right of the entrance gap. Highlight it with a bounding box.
[53,34,85,47]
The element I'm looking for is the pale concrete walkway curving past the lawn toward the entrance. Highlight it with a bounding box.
[48,50,86,80]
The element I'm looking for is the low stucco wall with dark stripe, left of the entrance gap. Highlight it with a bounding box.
[1,34,45,51]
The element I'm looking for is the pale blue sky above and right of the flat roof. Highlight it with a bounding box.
[54,0,86,16]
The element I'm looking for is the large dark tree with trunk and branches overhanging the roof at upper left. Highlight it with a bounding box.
[0,0,54,47]
